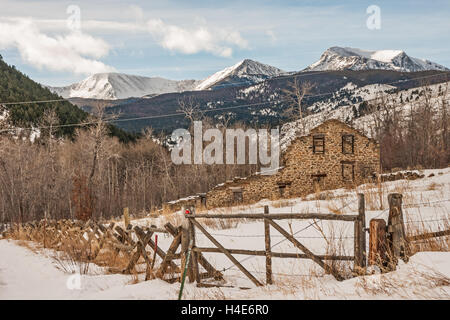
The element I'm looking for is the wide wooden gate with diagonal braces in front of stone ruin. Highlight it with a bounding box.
[178,194,366,286]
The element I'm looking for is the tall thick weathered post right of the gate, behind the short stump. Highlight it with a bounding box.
[388,193,408,270]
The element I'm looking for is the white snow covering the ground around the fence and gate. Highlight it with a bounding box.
[0,168,450,299]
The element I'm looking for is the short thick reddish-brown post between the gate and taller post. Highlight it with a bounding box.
[369,219,387,270]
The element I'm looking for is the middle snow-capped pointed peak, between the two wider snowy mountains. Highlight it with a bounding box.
[196,59,285,90]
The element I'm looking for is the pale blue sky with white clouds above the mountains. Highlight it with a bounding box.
[0,0,450,86]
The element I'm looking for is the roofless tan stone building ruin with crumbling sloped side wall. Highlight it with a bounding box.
[162,119,380,208]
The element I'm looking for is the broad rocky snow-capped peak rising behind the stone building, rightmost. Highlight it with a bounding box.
[304,47,449,72]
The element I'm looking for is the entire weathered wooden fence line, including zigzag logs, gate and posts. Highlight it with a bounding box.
[3,194,450,286]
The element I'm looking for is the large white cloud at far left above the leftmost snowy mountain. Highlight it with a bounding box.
[0,18,115,75]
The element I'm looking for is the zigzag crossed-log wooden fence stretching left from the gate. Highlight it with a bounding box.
[3,215,222,282]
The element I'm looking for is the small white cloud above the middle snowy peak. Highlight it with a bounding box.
[147,19,248,57]
